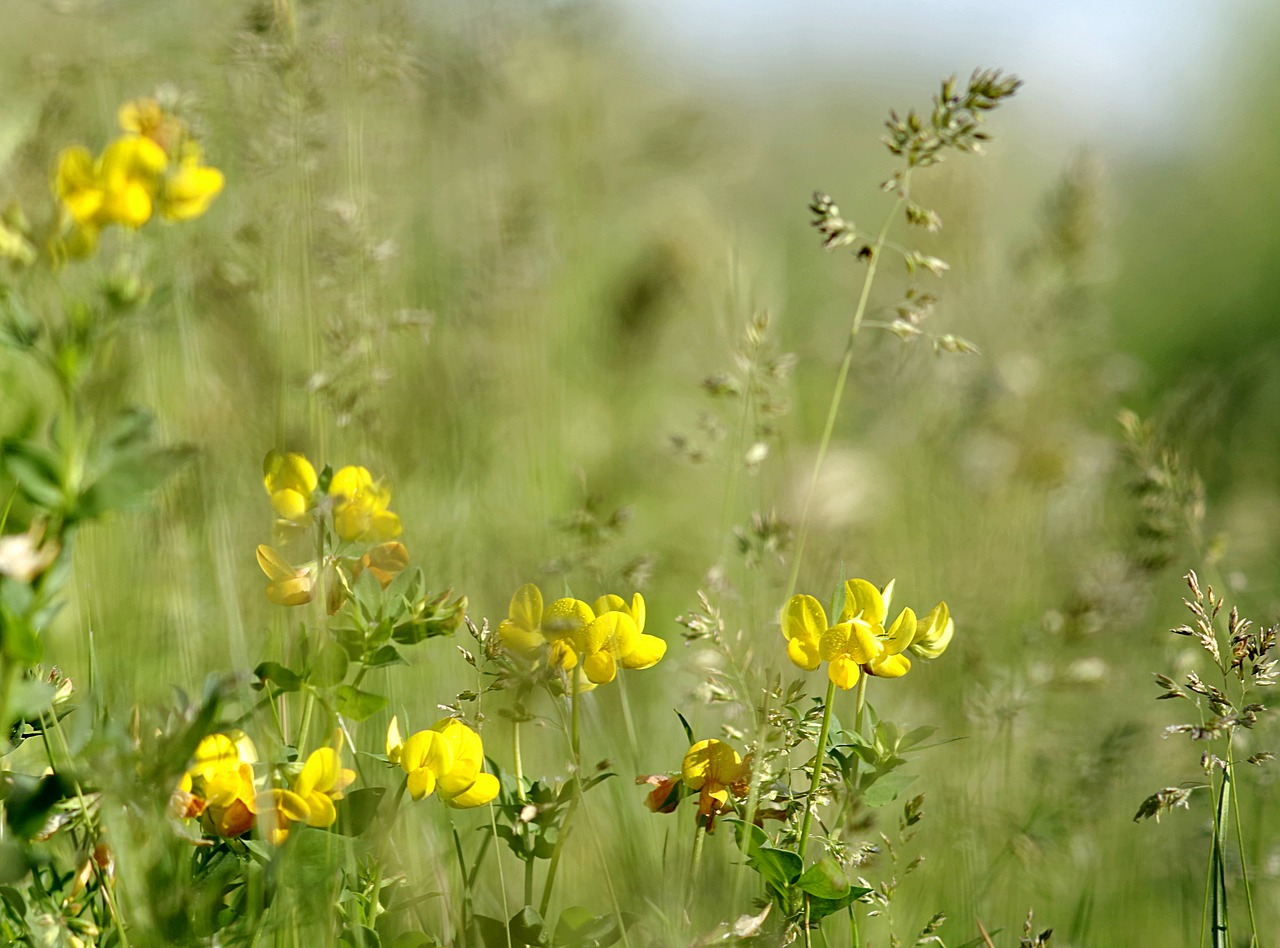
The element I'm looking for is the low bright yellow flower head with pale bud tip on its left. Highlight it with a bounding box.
[387,718,499,809]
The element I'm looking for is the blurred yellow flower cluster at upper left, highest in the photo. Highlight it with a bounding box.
[54,99,224,256]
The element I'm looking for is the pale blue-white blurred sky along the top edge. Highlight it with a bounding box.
[622,0,1270,151]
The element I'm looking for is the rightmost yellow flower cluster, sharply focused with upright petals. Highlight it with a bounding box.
[782,580,955,690]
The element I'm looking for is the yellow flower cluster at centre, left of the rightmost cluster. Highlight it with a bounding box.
[498,583,667,687]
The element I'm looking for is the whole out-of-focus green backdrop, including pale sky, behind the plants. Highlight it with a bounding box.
[0,0,1280,947]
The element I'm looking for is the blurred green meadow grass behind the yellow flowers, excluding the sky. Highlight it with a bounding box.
[0,0,1280,948]
